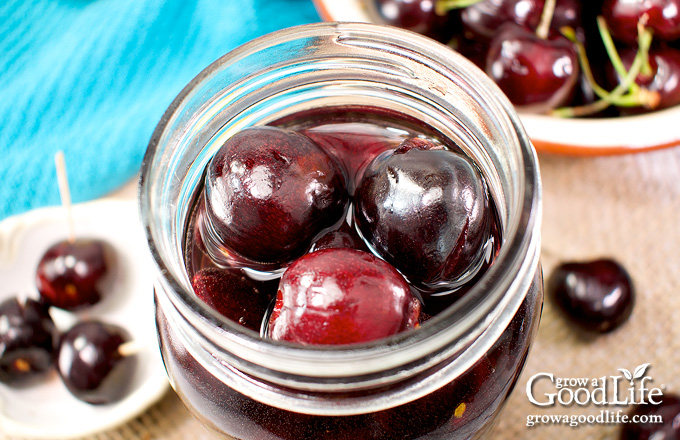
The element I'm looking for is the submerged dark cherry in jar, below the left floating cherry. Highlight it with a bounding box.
[192,268,278,332]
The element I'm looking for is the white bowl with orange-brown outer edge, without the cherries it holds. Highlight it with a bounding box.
[314,0,680,155]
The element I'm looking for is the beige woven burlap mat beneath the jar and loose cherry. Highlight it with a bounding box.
[0,147,680,440]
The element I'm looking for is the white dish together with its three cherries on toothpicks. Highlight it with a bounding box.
[0,200,169,438]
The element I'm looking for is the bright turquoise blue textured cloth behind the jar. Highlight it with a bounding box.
[0,0,319,219]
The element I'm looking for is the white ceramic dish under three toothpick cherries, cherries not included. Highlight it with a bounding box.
[0,201,169,439]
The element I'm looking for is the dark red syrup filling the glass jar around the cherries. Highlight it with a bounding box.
[162,108,542,440]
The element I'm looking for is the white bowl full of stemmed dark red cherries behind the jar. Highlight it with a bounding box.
[314,0,680,155]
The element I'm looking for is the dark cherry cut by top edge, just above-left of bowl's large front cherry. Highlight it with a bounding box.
[461,0,545,41]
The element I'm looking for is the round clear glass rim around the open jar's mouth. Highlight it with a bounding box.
[139,22,541,377]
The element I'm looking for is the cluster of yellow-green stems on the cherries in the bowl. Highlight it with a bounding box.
[551,16,659,117]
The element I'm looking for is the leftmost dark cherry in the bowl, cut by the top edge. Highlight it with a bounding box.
[375,0,456,42]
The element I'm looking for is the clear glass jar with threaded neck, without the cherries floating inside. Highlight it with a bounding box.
[140,23,543,440]
